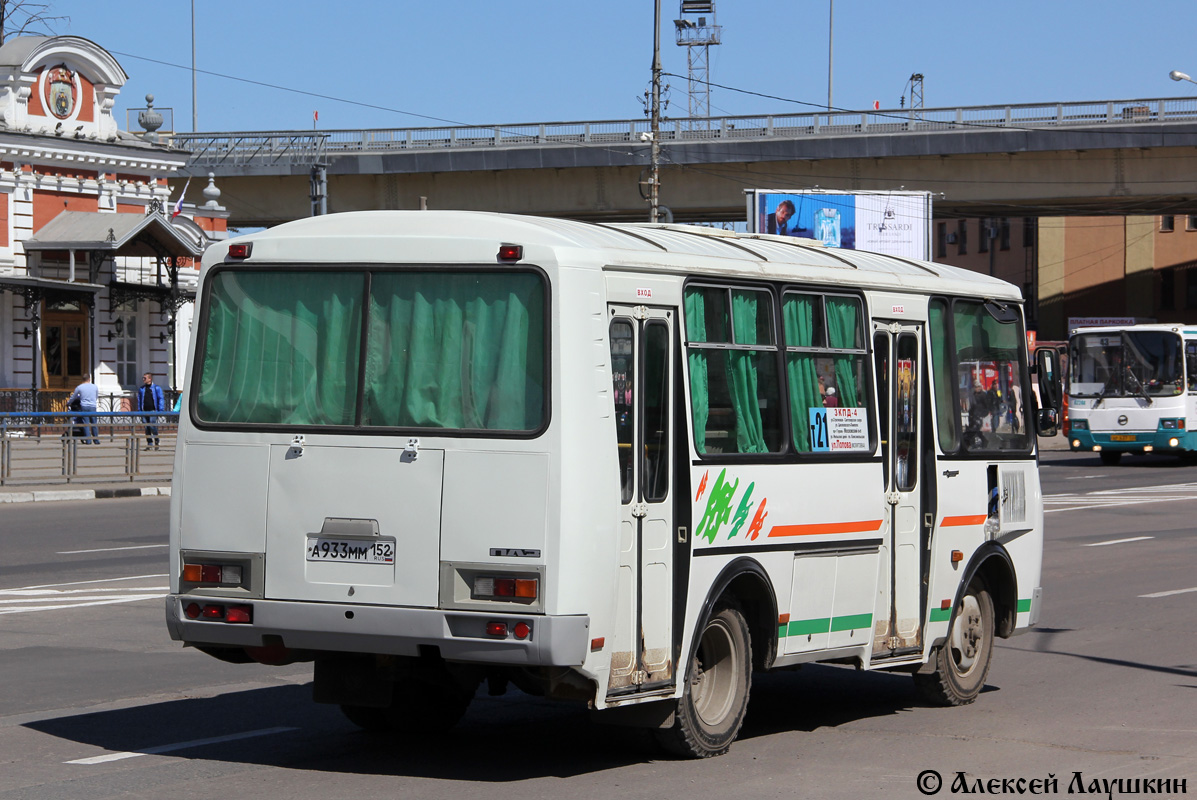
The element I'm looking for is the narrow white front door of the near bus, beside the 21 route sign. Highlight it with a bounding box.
[873,323,924,657]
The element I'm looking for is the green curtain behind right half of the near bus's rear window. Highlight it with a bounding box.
[363,272,545,430]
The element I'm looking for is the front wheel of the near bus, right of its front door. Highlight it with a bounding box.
[915,581,995,705]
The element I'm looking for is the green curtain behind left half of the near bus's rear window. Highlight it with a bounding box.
[198,272,365,425]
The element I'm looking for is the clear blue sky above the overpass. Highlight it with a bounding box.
[41,0,1197,133]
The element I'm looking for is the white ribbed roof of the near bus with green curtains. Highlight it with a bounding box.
[203,211,1022,302]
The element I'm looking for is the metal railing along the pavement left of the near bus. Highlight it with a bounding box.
[0,411,178,486]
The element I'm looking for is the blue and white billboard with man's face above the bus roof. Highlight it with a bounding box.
[747,189,931,261]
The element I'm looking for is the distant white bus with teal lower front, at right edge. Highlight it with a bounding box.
[1064,325,1197,465]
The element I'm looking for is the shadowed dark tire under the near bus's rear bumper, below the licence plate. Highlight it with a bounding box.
[341,680,474,737]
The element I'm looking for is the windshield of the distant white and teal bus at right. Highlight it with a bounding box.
[1069,331,1184,398]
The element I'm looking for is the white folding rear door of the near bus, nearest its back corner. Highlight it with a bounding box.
[608,305,675,695]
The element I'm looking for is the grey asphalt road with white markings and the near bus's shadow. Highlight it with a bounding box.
[0,451,1197,800]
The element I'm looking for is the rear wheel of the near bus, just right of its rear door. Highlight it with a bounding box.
[656,604,752,758]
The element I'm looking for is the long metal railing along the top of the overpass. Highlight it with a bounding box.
[171,97,1197,168]
